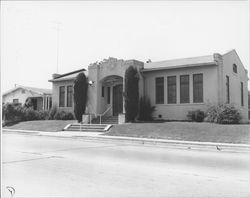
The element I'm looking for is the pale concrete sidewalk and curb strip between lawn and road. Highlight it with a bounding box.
[3,129,250,153]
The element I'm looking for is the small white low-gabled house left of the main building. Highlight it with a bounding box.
[2,86,52,110]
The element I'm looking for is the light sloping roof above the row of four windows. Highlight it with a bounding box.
[144,55,216,70]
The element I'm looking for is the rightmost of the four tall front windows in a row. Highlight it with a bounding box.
[193,74,203,103]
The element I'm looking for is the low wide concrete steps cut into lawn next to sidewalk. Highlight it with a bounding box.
[63,123,112,132]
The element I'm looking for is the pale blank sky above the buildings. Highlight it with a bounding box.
[1,1,250,92]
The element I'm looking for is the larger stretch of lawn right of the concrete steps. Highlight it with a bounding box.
[105,122,250,144]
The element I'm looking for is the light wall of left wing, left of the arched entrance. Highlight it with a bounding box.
[52,80,74,112]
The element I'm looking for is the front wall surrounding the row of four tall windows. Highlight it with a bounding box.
[143,65,218,120]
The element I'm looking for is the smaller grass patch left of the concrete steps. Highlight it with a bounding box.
[4,120,76,132]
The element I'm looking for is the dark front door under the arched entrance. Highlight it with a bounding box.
[113,85,123,116]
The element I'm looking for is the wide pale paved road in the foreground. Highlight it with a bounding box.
[2,133,250,198]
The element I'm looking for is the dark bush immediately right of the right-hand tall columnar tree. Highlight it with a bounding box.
[138,97,155,121]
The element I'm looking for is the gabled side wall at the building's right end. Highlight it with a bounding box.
[222,50,248,122]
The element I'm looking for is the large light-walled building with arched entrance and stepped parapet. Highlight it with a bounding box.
[50,50,248,121]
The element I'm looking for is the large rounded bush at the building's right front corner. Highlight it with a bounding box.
[205,104,241,124]
